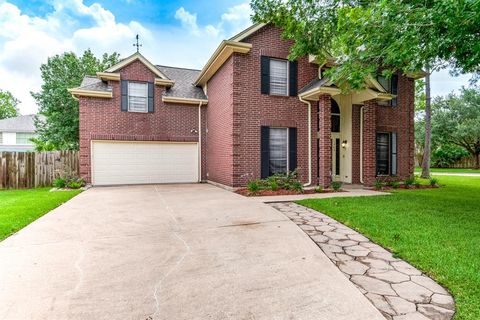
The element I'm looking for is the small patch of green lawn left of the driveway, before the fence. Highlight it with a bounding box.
[0,188,81,241]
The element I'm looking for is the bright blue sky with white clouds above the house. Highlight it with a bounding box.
[0,0,469,114]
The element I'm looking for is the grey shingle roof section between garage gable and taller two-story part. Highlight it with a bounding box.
[157,65,207,100]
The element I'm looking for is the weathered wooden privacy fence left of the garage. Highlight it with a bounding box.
[0,151,79,189]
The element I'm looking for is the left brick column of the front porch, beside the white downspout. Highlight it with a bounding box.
[318,94,332,188]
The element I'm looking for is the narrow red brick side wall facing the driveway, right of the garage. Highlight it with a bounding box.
[207,57,233,186]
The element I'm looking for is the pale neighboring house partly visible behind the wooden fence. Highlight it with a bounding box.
[0,114,36,151]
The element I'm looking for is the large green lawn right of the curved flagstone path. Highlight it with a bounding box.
[299,176,480,320]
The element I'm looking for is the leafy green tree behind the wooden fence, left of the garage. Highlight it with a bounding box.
[32,50,119,149]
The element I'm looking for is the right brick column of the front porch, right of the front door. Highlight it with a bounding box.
[363,100,377,186]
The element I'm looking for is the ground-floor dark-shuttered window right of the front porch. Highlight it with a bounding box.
[376,132,397,176]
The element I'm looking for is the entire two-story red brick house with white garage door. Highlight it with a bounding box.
[70,24,415,187]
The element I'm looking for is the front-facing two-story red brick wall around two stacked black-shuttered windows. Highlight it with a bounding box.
[232,26,318,186]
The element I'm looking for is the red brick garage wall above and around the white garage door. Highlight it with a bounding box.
[79,61,206,182]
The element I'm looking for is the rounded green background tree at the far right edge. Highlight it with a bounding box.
[432,89,480,169]
